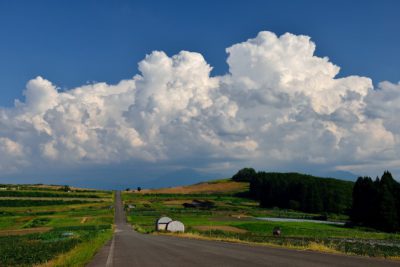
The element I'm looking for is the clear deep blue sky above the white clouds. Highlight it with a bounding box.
[0,0,400,106]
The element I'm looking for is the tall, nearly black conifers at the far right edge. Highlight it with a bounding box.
[351,171,400,232]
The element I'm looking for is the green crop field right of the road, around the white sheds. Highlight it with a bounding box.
[123,182,400,258]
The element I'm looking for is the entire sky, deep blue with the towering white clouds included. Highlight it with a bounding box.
[0,0,400,188]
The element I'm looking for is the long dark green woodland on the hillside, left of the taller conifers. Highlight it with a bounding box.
[247,171,354,213]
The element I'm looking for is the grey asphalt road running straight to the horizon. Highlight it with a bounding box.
[88,192,400,267]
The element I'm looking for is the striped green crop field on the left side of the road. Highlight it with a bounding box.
[0,185,114,266]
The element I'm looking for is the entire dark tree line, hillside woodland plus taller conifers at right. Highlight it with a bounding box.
[232,168,400,232]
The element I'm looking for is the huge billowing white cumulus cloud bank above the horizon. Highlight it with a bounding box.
[0,32,400,180]
